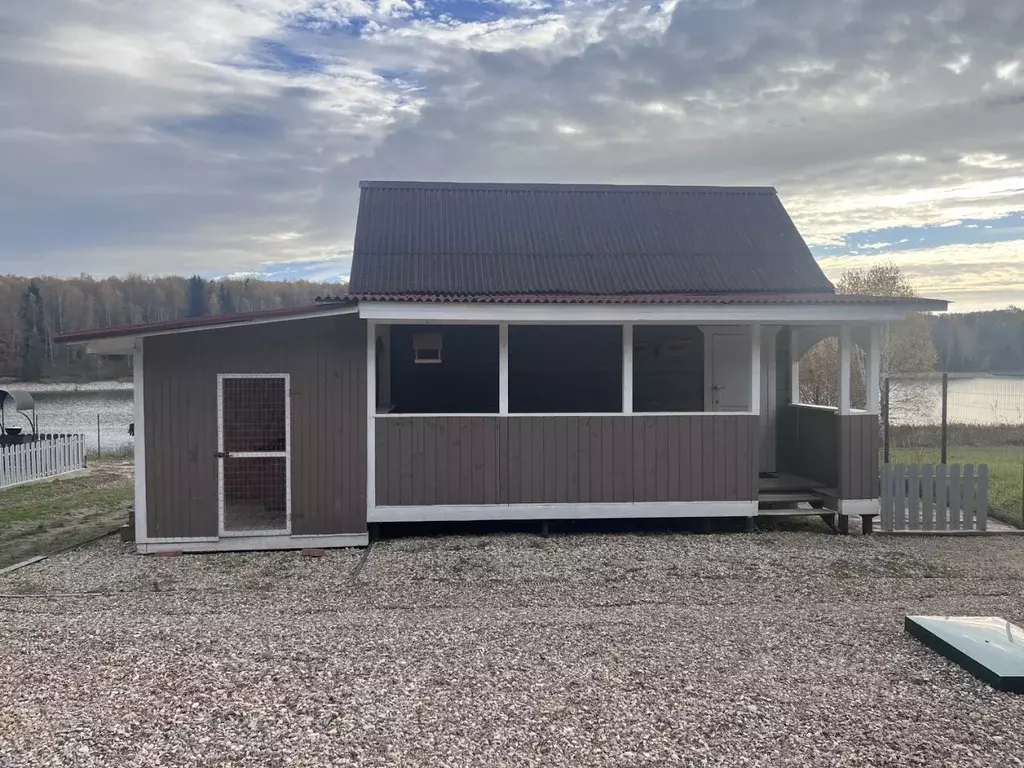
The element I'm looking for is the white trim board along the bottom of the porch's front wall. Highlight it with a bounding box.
[367,501,758,522]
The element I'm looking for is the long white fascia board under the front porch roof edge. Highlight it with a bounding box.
[358,301,929,326]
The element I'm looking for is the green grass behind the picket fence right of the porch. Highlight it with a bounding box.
[892,445,1024,527]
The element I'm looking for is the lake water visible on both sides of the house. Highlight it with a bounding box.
[3,377,1024,451]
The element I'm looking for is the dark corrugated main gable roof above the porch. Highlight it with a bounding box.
[349,181,834,299]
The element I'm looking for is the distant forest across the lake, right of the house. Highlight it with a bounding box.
[932,306,1024,374]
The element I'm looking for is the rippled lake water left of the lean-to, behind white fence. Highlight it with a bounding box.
[2,381,135,451]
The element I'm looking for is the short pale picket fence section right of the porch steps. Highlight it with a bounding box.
[882,464,988,530]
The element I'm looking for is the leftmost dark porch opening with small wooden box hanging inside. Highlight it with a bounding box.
[378,326,498,414]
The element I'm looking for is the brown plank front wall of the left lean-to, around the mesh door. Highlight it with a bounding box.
[142,315,367,538]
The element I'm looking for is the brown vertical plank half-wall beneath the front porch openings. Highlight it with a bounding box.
[376,415,760,506]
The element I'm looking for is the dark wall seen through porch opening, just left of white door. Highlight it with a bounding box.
[633,326,705,413]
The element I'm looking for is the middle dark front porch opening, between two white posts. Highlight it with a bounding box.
[509,326,623,414]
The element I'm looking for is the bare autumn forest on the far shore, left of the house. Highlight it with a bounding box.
[0,275,345,381]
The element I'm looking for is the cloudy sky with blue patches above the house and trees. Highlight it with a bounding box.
[0,0,1024,310]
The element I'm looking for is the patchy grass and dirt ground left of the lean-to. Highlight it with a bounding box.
[0,460,133,567]
